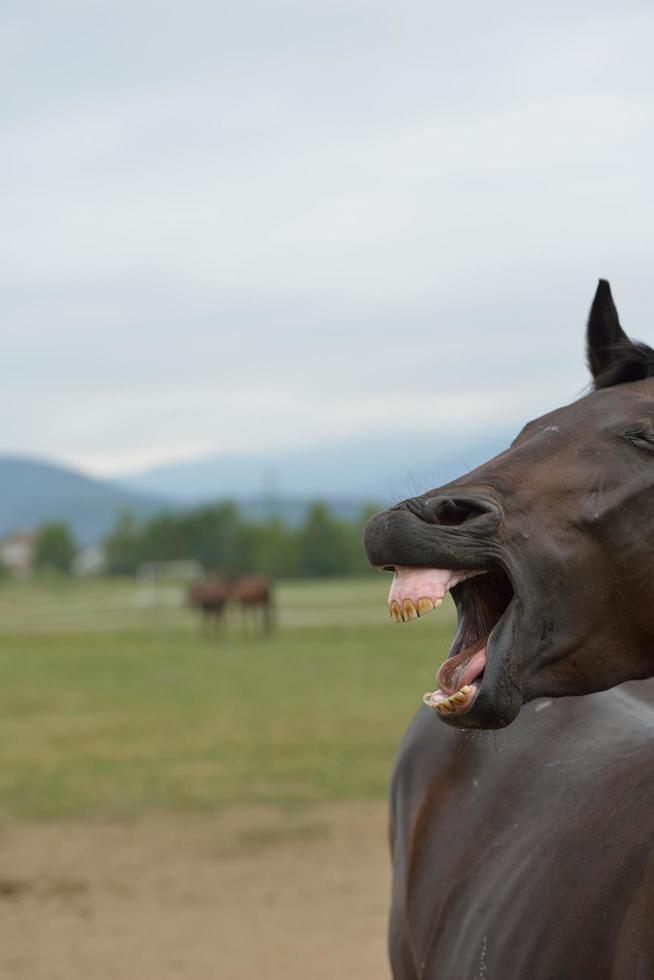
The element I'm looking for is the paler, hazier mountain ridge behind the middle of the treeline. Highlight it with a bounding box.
[117,433,509,508]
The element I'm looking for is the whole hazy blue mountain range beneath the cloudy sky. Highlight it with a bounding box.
[0,433,508,544]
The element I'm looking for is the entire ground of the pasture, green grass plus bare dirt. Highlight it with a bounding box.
[0,575,453,980]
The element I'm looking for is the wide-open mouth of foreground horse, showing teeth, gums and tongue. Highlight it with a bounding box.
[388,566,514,718]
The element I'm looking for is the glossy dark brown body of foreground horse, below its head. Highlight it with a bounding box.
[390,690,654,980]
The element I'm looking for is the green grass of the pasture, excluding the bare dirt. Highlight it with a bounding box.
[0,576,453,818]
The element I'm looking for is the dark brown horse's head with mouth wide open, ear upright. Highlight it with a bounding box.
[365,280,654,728]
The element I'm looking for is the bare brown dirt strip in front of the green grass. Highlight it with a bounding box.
[0,804,389,980]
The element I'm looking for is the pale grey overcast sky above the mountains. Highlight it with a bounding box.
[5,0,654,475]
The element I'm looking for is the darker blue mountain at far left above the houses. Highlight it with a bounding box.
[0,456,170,544]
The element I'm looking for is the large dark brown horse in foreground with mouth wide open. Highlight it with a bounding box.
[365,280,654,980]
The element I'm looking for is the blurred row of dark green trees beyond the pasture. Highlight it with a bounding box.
[28,503,376,578]
